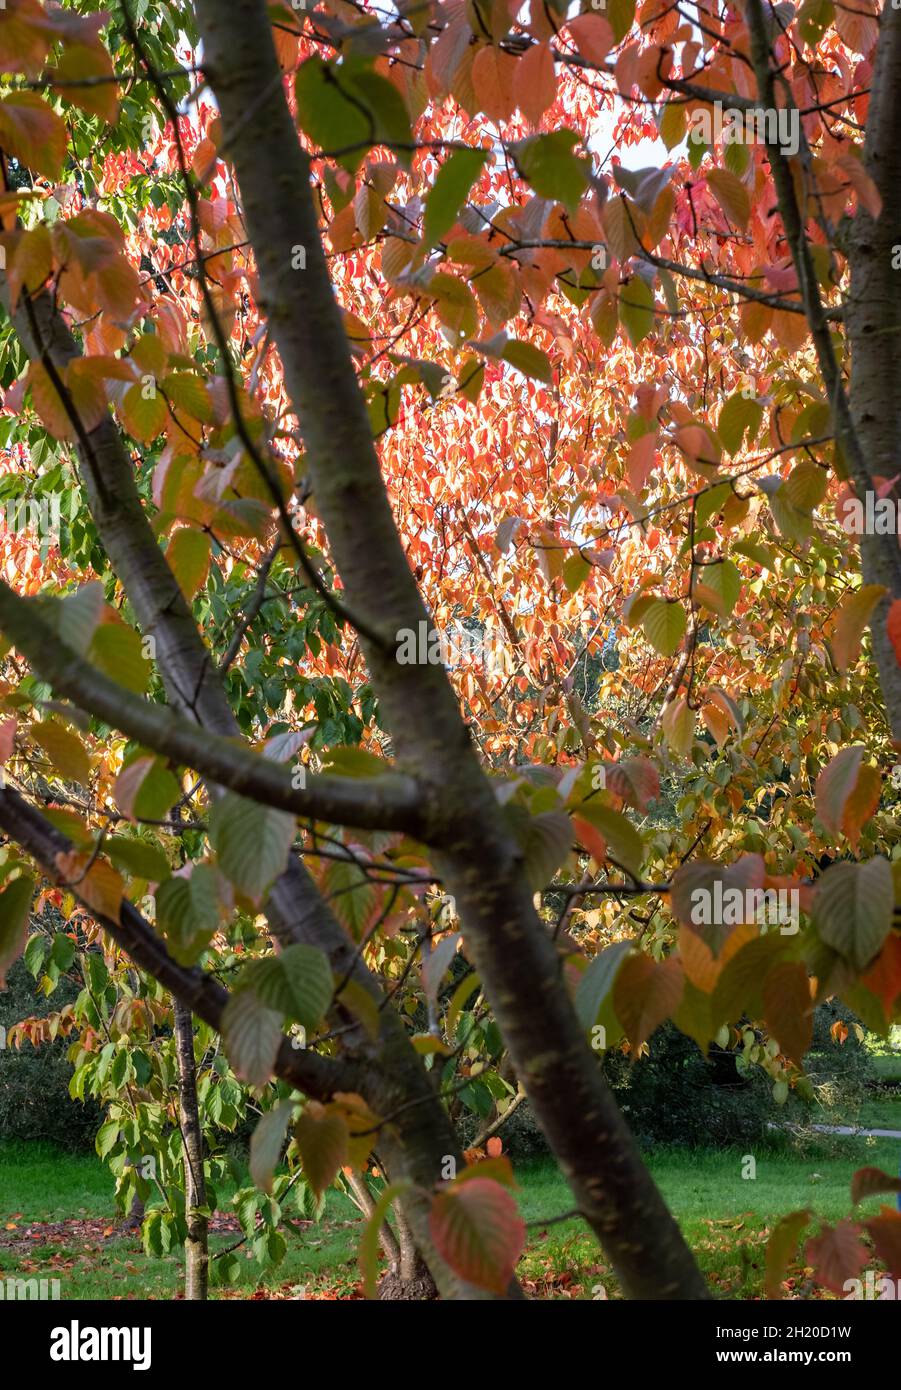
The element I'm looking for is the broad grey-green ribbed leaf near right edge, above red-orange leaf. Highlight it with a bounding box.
[813,856,894,972]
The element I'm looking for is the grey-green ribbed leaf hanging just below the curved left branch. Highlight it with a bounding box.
[210,792,295,902]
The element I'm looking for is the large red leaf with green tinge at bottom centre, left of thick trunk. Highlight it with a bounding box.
[430,1177,526,1297]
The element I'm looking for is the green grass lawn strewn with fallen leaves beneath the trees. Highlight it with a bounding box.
[7,1137,901,1298]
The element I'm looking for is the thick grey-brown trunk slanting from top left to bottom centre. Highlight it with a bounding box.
[196,0,708,1298]
